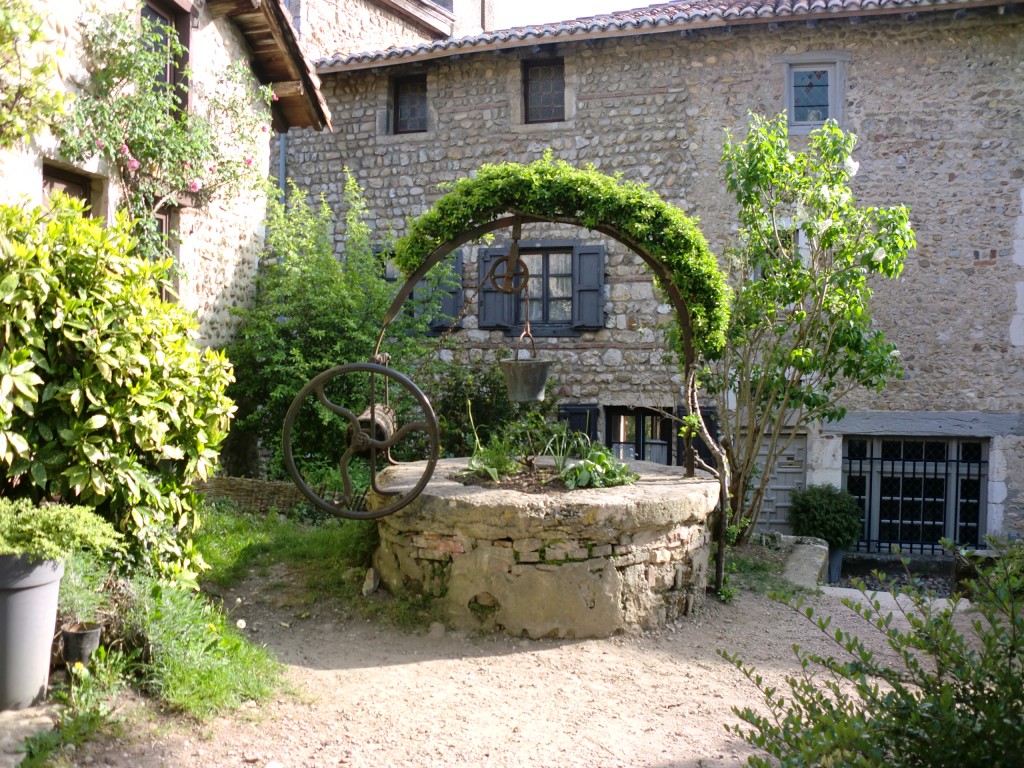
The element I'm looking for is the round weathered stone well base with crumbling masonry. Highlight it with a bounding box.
[368,459,718,638]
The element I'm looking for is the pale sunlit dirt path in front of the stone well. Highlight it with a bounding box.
[76,583,880,768]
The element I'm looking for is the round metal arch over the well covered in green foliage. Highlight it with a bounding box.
[378,151,729,369]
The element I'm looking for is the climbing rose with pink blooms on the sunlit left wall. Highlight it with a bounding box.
[54,10,273,258]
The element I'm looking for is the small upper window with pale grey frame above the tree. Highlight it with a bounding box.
[773,51,851,133]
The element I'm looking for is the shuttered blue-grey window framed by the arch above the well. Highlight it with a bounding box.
[478,241,604,336]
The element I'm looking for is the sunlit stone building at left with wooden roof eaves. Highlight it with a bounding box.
[0,0,330,346]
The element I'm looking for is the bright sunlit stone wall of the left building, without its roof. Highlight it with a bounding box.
[0,0,270,346]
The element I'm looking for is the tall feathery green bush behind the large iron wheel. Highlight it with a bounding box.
[227,177,443,477]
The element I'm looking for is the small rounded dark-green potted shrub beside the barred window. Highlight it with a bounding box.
[790,484,864,584]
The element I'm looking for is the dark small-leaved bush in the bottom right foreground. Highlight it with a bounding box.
[719,542,1024,768]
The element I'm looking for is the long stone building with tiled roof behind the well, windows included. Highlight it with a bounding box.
[282,0,1024,550]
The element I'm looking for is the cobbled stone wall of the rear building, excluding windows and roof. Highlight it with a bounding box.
[286,8,1024,548]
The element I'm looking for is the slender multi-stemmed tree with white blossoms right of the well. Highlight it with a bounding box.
[691,114,915,542]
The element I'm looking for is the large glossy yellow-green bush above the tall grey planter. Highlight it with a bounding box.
[0,198,232,578]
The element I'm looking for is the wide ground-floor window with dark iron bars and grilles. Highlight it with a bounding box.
[843,437,988,553]
